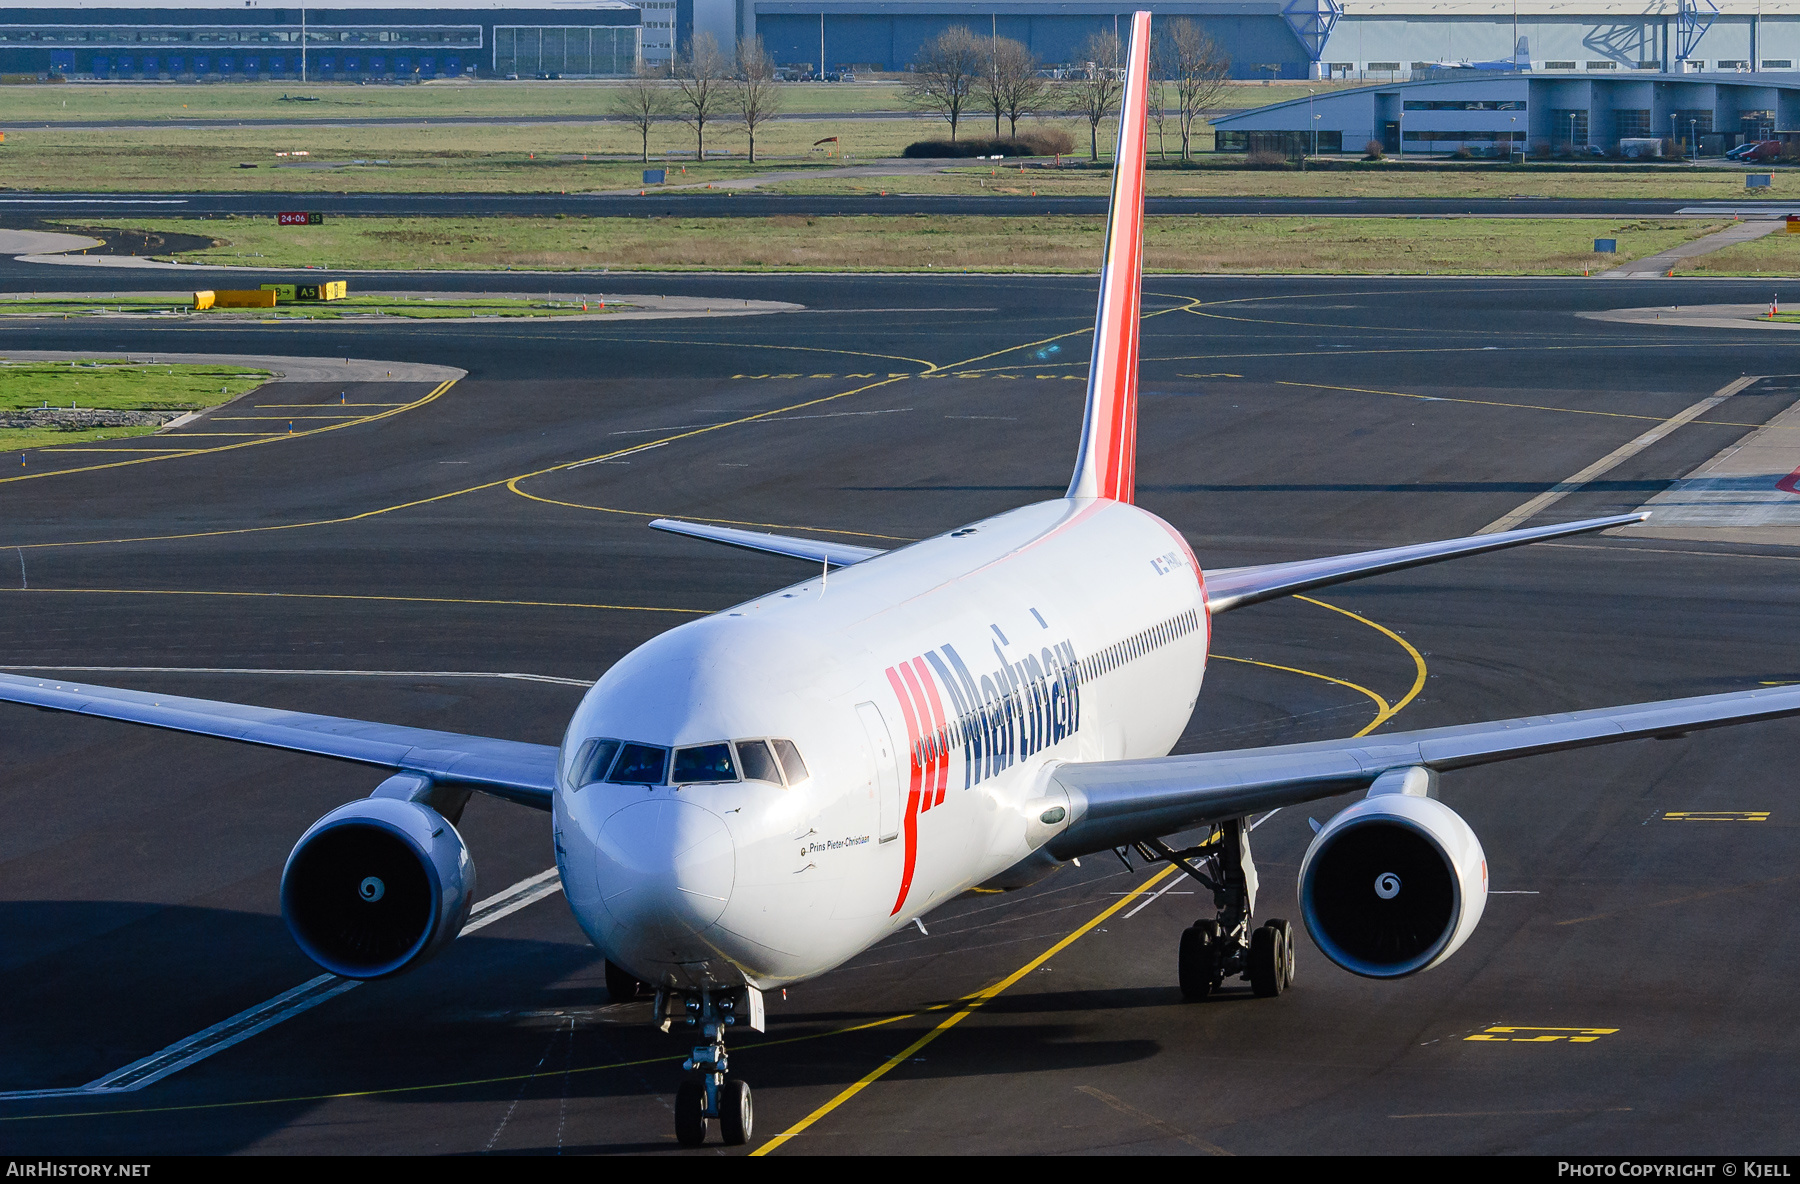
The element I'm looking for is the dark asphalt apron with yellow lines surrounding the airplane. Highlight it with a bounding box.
[0,271,1800,1155]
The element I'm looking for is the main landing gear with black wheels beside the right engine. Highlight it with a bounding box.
[1139,819,1294,1000]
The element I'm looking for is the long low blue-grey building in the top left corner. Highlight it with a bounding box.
[0,0,648,81]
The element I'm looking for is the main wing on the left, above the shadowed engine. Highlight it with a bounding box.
[0,675,556,810]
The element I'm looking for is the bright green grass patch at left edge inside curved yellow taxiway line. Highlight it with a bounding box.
[0,358,270,452]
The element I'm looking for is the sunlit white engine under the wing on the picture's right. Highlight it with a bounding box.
[1300,794,1487,979]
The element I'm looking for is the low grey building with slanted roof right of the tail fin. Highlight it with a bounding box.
[1211,70,1800,155]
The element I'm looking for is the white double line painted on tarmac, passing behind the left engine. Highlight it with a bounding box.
[0,856,562,1101]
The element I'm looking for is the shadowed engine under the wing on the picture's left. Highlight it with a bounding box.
[281,797,475,979]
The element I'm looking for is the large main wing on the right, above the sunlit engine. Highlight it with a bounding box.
[1048,676,1800,858]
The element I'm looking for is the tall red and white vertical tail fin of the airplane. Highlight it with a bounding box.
[1069,13,1150,502]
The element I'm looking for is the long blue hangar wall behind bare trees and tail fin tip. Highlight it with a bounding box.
[747,0,1312,79]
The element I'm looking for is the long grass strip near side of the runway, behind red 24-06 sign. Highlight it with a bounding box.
[87,216,1723,273]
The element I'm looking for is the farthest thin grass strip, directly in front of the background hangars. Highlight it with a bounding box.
[0,81,1343,124]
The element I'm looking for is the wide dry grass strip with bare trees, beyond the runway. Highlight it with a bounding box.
[0,110,1778,200]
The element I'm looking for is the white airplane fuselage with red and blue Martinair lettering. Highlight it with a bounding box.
[554,498,1210,988]
